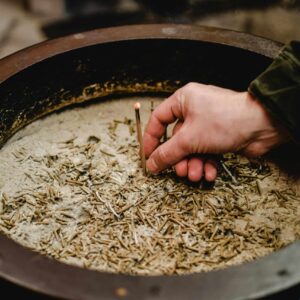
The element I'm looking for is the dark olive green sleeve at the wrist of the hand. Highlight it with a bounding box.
[248,41,300,142]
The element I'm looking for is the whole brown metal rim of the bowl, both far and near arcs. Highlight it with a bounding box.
[0,24,300,300]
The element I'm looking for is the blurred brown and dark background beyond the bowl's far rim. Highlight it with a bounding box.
[0,0,300,58]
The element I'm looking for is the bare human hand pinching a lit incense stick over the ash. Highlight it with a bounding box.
[144,83,288,181]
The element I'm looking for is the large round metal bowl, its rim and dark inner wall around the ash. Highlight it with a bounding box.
[0,25,300,300]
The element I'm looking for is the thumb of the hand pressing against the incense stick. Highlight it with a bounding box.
[147,128,190,174]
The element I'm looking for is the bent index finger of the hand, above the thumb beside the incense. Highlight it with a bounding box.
[144,90,182,157]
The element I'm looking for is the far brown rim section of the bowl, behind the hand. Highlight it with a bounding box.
[0,24,282,83]
